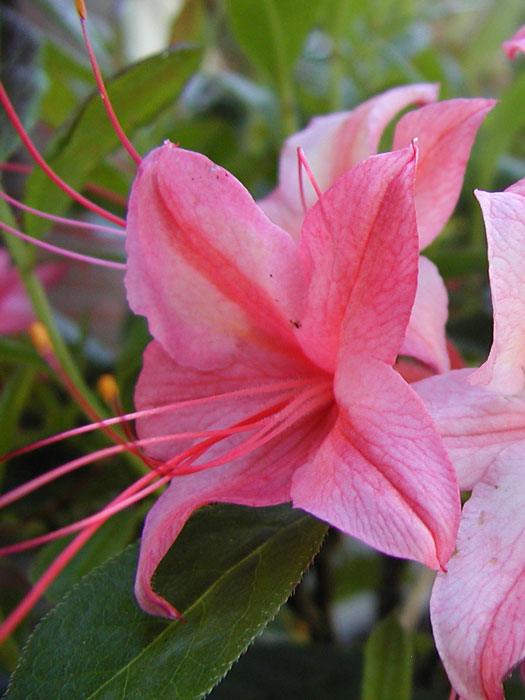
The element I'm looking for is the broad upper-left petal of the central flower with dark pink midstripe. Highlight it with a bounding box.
[126,144,304,369]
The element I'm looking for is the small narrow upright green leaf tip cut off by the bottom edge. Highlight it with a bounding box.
[362,615,413,700]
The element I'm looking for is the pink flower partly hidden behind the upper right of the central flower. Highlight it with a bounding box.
[260,84,494,372]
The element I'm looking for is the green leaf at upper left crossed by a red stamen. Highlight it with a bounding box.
[26,47,200,235]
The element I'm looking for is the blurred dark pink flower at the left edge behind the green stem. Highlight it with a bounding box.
[0,249,64,335]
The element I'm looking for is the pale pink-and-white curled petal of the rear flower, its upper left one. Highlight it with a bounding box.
[260,83,439,236]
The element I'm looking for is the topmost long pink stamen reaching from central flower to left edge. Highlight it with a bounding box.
[0,379,307,464]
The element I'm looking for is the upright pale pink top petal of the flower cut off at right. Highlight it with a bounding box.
[472,180,525,394]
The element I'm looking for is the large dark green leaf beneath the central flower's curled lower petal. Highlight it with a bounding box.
[6,506,326,700]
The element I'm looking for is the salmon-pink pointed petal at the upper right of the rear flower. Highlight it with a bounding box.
[394,98,495,249]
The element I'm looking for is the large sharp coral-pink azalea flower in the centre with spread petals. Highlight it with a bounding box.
[126,144,459,617]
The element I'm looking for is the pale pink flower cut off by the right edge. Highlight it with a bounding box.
[414,180,525,700]
